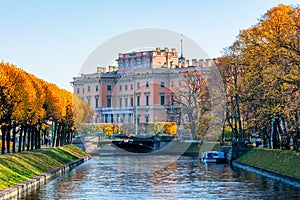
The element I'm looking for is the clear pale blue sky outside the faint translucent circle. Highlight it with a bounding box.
[0,0,299,91]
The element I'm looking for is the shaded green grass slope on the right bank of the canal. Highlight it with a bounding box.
[237,149,300,179]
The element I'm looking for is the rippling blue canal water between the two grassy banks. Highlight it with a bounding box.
[21,156,300,200]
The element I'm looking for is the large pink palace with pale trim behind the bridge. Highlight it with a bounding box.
[72,48,214,134]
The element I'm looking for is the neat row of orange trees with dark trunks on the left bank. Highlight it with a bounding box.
[0,62,92,154]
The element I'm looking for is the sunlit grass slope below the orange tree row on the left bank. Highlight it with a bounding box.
[0,145,86,190]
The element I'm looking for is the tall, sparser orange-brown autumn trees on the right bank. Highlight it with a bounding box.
[218,5,300,148]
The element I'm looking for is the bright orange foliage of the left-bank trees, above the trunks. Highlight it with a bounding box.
[0,62,92,152]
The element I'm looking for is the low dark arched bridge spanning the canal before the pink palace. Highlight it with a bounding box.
[73,135,195,155]
